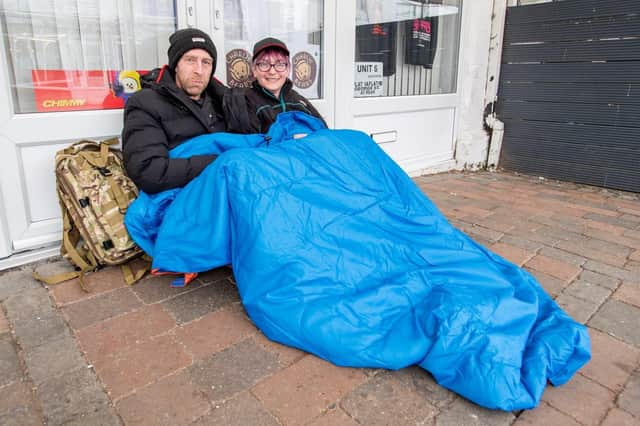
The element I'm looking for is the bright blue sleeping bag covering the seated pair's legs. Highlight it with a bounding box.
[125,112,590,411]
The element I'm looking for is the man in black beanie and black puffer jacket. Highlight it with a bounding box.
[122,28,226,194]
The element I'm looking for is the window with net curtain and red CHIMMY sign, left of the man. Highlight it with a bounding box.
[0,0,176,113]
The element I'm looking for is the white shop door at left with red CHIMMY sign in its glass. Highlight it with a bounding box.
[0,0,176,269]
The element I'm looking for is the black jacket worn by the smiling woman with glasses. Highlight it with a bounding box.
[224,79,327,133]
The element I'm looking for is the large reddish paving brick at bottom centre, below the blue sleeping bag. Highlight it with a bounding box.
[252,355,366,424]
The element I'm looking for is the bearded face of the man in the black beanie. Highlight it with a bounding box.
[176,49,213,100]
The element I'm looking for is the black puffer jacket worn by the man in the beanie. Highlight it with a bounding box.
[122,66,227,194]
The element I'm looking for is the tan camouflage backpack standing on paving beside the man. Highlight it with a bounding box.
[36,138,148,290]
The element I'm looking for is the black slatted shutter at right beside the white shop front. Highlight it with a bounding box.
[497,0,640,192]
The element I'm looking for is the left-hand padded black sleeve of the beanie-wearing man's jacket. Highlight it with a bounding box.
[122,96,216,194]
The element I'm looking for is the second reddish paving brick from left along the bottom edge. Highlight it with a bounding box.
[116,370,211,426]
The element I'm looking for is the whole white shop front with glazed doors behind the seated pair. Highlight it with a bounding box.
[0,0,470,269]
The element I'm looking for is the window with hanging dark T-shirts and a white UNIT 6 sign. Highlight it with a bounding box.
[354,0,462,97]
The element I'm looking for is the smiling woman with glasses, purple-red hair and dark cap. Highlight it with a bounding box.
[225,37,326,133]
